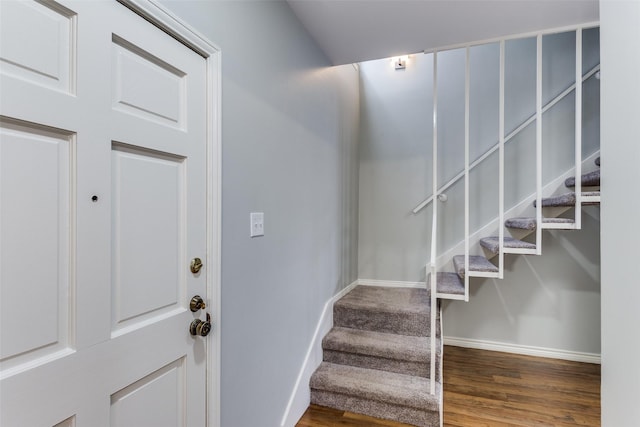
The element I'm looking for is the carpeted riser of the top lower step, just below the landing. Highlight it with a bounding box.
[333,305,440,337]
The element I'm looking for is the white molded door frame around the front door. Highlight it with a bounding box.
[117,0,222,427]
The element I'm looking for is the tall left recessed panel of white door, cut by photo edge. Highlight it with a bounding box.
[0,119,74,372]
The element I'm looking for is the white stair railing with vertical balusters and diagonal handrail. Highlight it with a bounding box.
[422,27,600,400]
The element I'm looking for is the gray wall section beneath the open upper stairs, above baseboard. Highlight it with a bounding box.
[443,207,600,357]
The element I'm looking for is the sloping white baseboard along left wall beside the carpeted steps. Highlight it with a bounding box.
[280,280,359,427]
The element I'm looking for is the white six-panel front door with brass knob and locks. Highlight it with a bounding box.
[0,0,213,427]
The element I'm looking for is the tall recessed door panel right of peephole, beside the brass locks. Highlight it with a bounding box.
[112,145,187,330]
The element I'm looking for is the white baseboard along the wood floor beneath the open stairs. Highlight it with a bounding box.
[444,336,601,364]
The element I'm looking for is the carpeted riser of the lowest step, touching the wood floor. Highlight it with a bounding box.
[311,389,440,427]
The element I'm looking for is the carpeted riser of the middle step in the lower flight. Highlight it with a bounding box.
[323,350,440,378]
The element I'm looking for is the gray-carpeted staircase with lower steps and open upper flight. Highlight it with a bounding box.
[310,157,600,427]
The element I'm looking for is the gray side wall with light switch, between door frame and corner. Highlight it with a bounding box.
[157,1,359,427]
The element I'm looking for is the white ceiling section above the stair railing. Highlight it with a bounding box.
[287,0,599,65]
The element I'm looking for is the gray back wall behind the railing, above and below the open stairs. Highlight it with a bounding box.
[358,29,600,354]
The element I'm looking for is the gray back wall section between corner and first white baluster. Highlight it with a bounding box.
[358,55,433,280]
